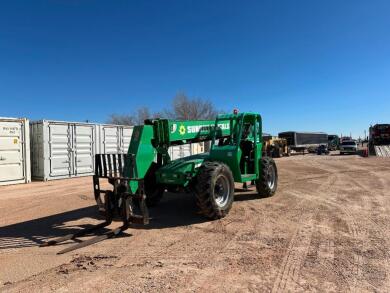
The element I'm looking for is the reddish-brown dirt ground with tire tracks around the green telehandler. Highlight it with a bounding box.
[0,155,390,292]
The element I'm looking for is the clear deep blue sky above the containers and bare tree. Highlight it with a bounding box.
[0,0,390,136]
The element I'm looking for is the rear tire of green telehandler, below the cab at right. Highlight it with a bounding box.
[256,157,278,197]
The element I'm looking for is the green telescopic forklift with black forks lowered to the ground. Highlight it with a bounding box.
[42,110,278,253]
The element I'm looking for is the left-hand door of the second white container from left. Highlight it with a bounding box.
[49,123,72,177]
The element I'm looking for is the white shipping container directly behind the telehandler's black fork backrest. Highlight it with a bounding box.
[98,124,133,154]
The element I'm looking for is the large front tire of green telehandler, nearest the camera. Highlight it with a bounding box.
[195,162,234,219]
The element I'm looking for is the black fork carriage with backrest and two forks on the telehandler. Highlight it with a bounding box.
[40,154,149,254]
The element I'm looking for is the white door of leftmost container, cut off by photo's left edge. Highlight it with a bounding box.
[0,122,25,182]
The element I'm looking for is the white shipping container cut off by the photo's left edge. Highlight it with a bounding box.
[0,118,31,185]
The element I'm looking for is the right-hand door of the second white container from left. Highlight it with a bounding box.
[73,125,95,175]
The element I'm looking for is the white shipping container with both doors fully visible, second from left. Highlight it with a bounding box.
[30,120,99,181]
